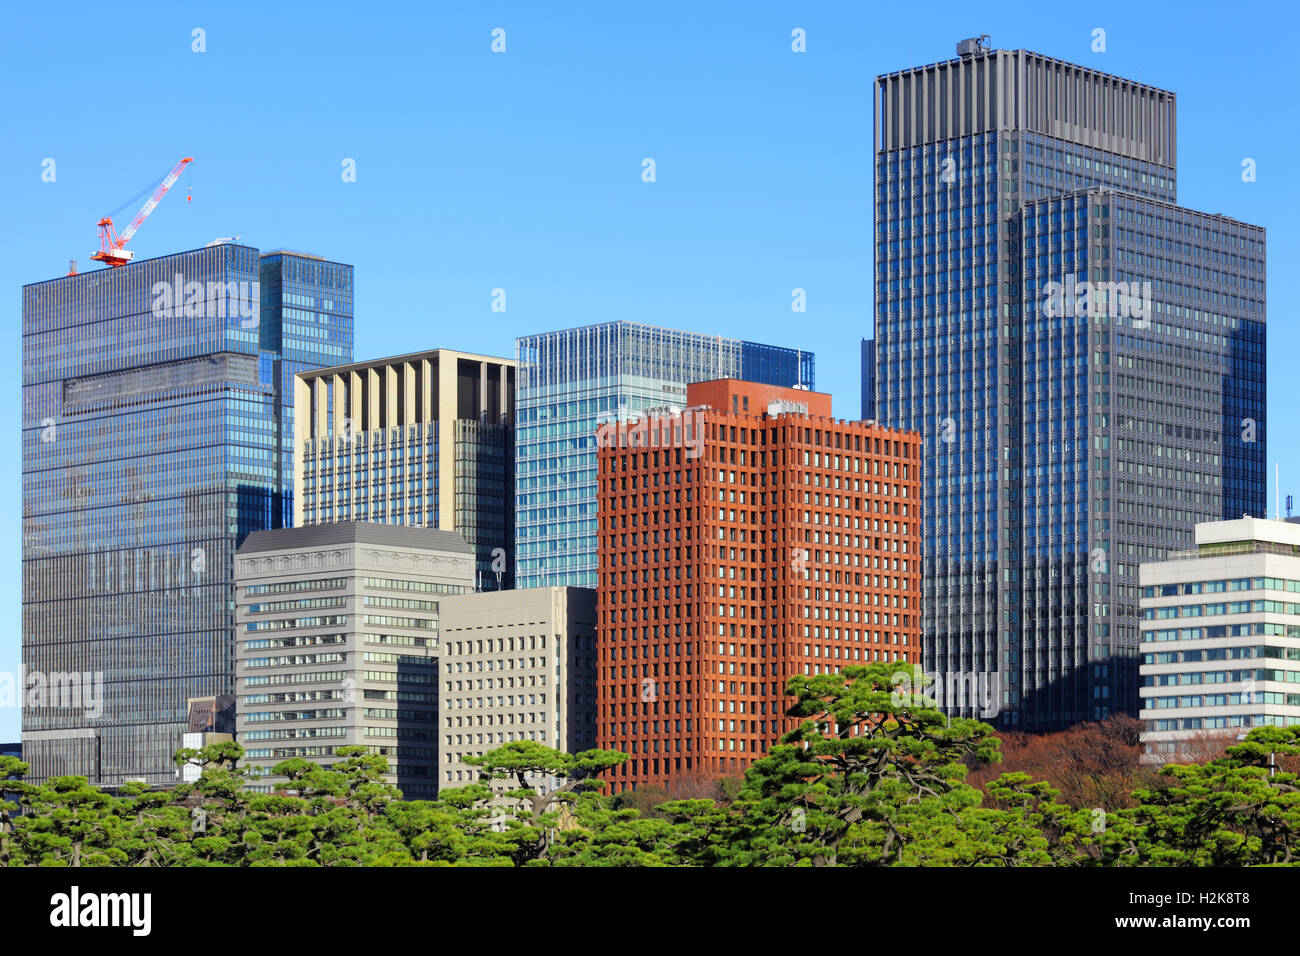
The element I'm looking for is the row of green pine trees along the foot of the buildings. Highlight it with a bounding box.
[0,662,1300,866]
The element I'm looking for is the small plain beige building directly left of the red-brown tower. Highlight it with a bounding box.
[439,588,595,790]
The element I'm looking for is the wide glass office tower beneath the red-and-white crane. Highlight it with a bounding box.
[22,243,351,784]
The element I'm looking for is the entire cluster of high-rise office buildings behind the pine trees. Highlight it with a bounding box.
[22,42,1279,797]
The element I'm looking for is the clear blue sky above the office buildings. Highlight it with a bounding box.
[0,0,1300,740]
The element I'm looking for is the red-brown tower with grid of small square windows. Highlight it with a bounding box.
[597,380,922,790]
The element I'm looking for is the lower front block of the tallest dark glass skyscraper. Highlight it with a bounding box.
[1004,189,1265,726]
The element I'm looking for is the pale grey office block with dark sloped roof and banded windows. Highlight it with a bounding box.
[235,522,475,799]
